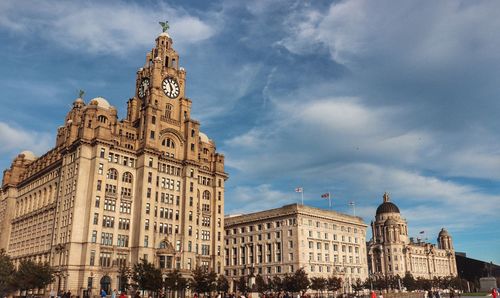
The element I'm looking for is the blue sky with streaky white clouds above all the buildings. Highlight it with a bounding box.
[0,0,500,264]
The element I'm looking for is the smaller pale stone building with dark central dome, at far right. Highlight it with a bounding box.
[367,193,457,278]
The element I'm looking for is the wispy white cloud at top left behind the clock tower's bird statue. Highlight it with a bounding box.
[0,1,215,55]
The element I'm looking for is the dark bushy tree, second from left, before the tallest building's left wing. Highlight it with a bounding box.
[13,260,54,291]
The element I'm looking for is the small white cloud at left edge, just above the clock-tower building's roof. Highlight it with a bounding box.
[0,122,54,157]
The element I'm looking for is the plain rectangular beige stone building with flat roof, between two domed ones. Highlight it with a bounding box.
[224,204,368,291]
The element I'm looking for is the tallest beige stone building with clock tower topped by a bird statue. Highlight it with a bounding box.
[0,32,228,295]
